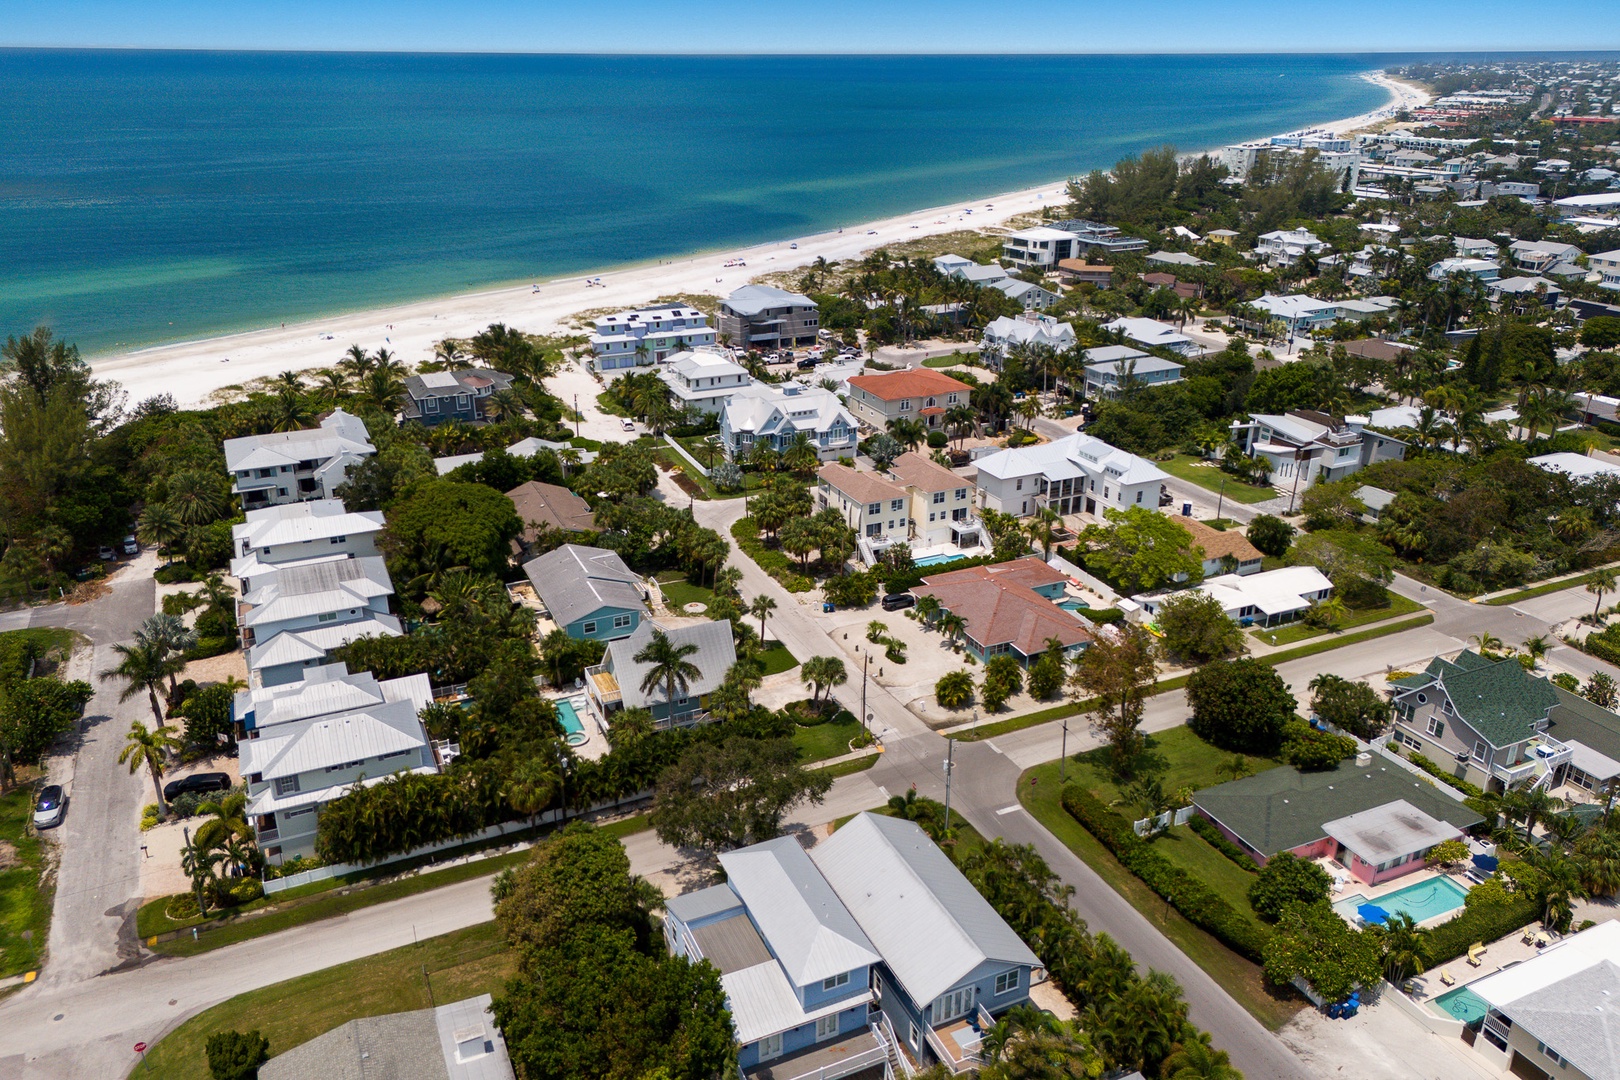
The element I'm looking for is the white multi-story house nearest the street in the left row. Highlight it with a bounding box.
[232,664,441,865]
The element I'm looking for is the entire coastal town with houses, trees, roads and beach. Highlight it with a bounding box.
[9,60,1620,1080]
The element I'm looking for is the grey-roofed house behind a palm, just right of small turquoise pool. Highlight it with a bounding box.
[585,619,737,730]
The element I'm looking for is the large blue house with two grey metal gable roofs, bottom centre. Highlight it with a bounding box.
[664,813,1047,1080]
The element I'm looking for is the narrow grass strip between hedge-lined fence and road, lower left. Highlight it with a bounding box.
[134,814,650,957]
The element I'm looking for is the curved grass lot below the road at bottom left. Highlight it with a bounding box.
[131,923,515,1080]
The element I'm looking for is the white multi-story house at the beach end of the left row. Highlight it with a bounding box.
[225,408,377,510]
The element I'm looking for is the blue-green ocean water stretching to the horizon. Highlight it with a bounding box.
[0,50,1388,351]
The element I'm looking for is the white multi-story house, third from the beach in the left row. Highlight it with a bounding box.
[237,555,402,687]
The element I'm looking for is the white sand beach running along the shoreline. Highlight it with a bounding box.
[91,71,1429,406]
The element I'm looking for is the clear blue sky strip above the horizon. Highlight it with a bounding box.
[9,0,1620,53]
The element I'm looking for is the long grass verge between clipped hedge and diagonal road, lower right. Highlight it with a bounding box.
[1017,761,1304,1031]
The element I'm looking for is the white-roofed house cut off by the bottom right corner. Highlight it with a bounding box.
[1468,921,1620,1080]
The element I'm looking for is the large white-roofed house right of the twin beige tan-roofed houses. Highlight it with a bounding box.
[974,432,1170,518]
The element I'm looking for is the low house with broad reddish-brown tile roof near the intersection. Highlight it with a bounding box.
[912,555,1094,667]
